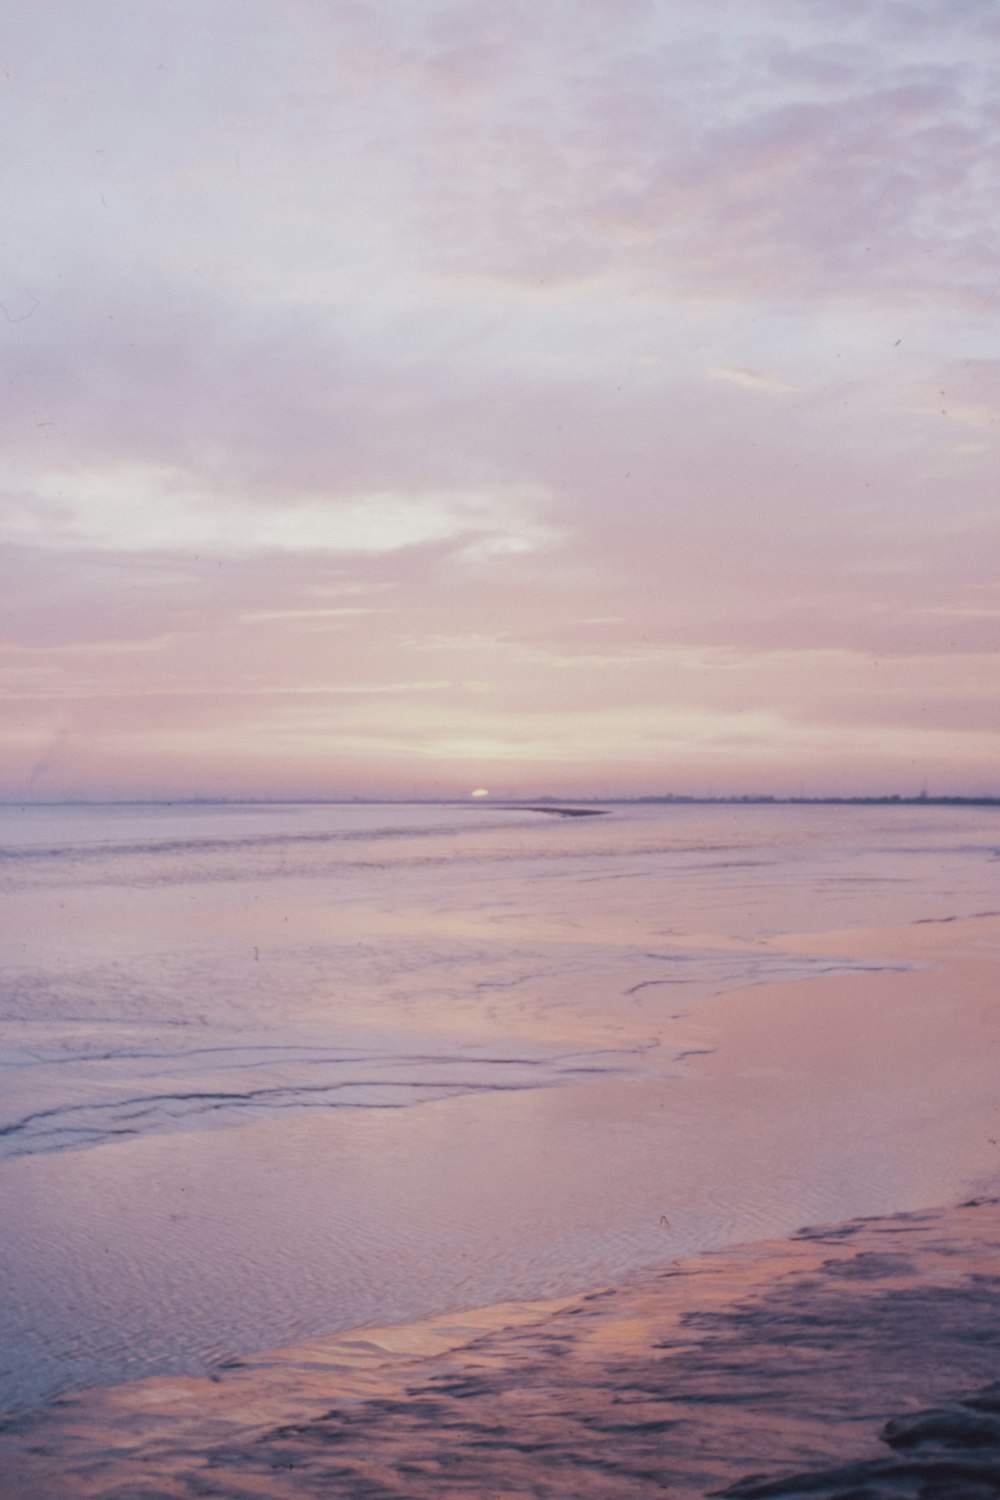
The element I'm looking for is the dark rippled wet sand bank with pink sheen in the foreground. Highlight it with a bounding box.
[0,1199,1000,1500]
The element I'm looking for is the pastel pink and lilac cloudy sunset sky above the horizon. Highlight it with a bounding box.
[0,0,1000,801]
